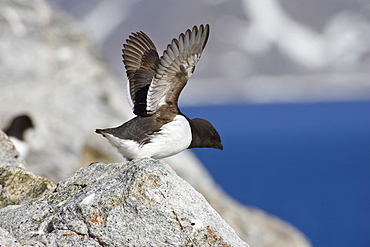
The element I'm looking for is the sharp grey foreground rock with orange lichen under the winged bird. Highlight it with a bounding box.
[0,159,247,246]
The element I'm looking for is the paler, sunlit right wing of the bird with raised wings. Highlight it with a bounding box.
[146,24,209,115]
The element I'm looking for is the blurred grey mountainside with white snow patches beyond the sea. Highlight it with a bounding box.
[50,0,370,106]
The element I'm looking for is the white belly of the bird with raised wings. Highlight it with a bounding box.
[106,115,191,160]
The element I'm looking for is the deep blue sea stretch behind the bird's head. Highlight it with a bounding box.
[182,102,370,247]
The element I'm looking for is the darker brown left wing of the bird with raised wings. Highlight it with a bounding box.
[122,32,159,116]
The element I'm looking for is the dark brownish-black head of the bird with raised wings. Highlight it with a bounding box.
[189,118,224,150]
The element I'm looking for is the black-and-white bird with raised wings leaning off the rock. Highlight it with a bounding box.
[96,24,223,160]
